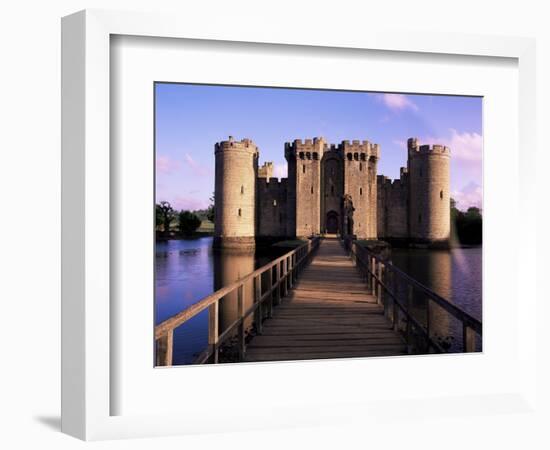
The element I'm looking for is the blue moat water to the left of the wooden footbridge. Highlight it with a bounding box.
[155,237,289,365]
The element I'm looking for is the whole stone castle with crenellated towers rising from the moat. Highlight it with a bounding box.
[214,136,450,248]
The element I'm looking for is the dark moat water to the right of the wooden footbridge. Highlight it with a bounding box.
[392,247,482,351]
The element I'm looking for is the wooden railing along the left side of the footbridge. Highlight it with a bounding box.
[155,238,319,366]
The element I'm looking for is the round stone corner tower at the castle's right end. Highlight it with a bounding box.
[407,138,451,245]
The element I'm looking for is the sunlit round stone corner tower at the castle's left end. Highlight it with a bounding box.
[214,136,258,249]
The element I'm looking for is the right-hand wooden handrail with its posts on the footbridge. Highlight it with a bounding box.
[344,240,482,352]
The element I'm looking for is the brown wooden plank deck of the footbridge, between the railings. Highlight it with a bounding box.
[245,239,406,361]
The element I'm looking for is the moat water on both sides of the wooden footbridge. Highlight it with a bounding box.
[155,237,482,365]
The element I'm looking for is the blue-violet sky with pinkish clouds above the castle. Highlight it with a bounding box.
[155,83,483,210]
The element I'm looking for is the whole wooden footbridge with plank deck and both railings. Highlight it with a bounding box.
[155,238,482,366]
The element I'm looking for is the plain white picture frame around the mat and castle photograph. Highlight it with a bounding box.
[62,10,536,440]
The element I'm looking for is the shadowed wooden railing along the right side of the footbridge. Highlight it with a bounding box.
[344,239,482,353]
